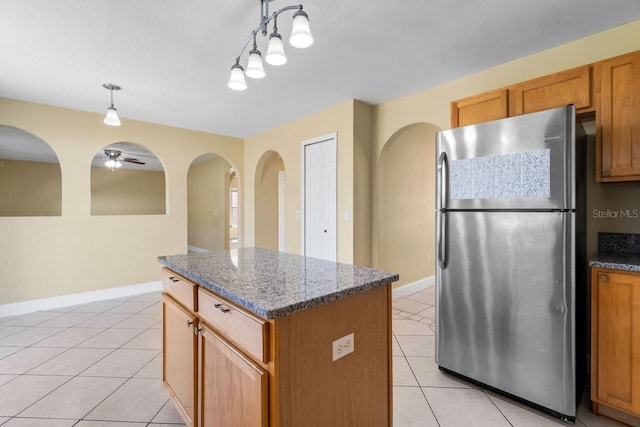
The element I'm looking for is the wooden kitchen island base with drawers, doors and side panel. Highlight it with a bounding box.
[162,272,393,427]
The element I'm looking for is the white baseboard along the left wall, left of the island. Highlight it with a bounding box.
[0,281,162,317]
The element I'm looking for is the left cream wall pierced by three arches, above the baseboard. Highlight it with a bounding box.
[0,98,244,304]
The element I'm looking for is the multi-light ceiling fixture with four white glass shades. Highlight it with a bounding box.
[229,0,313,90]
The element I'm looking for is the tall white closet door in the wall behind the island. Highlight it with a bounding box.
[302,134,338,261]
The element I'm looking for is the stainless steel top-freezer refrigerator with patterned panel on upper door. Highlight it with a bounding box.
[436,105,588,420]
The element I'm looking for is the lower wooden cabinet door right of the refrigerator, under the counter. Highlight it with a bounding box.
[594,271,640,414]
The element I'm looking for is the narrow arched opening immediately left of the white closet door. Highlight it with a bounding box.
[254,150,286,251]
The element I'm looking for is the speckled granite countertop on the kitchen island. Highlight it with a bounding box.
[158,248,399,319]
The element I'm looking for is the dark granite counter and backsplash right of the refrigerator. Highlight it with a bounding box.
[589,233,640,272]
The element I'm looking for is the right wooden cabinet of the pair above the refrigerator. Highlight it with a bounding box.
[509,65,594,116]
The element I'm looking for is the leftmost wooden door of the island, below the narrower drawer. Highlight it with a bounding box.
[162,294,198,426]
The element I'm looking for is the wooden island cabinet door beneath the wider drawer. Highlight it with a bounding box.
[198,323,268,427]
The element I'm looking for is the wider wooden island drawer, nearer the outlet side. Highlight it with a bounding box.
[198,288,269,363]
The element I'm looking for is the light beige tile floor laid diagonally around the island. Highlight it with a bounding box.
[0,287,617,427]
